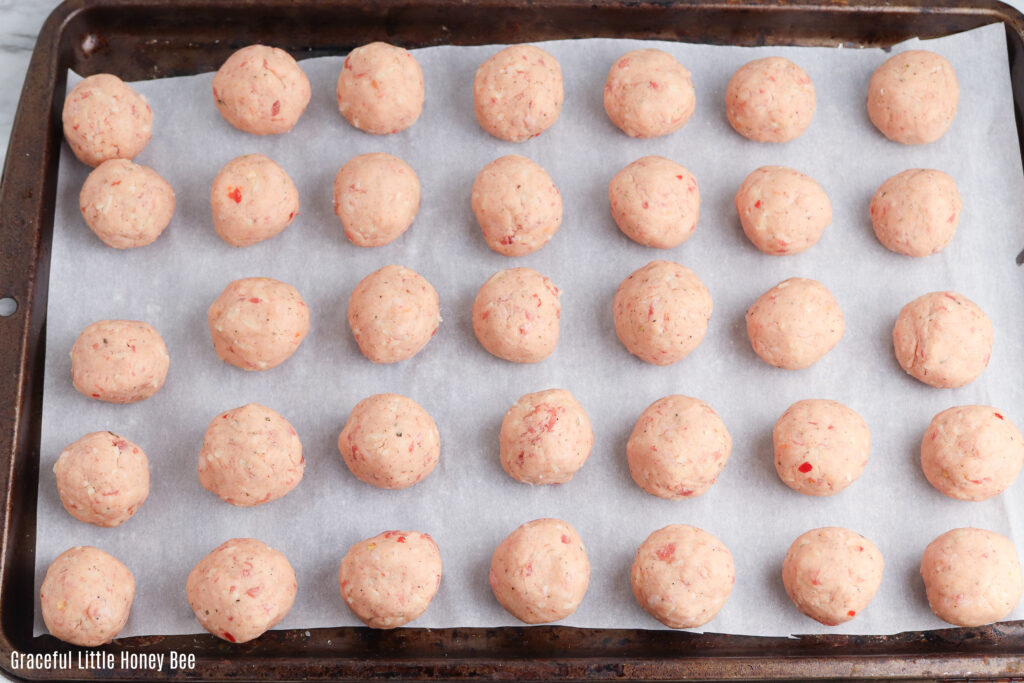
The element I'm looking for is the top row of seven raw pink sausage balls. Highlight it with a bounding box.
[62,37,959,166]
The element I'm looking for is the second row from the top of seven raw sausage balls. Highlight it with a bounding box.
[79,144,963,264]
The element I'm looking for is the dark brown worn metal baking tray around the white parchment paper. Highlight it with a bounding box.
[0,0,1024,680]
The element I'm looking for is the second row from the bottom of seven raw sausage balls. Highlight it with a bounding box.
[53,389,1024,527]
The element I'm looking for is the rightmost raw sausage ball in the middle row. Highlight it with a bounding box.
[893,292,992,388]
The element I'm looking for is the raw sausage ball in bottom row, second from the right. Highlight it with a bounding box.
[782,526,886,626]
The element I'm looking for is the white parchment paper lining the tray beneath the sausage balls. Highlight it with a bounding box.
[35,25,1024,636]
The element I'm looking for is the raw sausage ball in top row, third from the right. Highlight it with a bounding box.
[604,49,697,137]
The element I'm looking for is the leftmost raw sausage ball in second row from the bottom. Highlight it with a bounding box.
[53,432,150,526]
